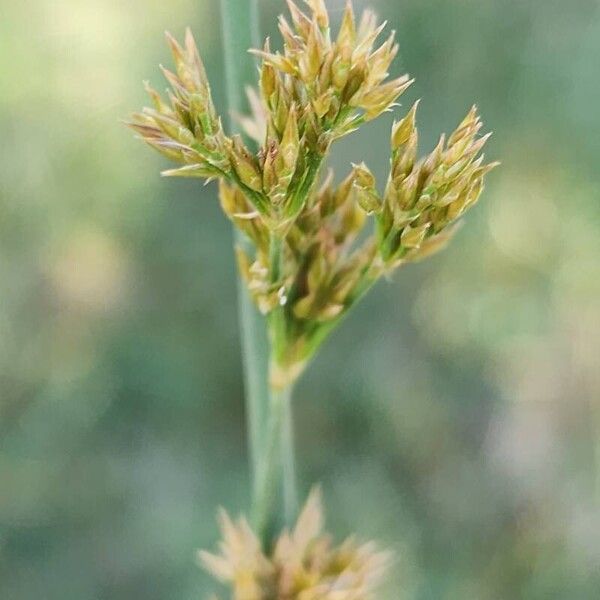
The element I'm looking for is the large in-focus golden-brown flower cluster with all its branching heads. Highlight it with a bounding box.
[131,0,496,386]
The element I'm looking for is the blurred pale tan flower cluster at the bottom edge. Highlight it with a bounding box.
[199,491,390,600]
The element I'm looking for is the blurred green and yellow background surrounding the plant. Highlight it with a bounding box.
[0,0,600,600]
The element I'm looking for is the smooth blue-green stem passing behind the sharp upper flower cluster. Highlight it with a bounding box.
[221,0,269,502]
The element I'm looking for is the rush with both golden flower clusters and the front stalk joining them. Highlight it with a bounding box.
[130,0,497,600]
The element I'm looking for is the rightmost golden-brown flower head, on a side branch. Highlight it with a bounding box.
[360,103,499,269]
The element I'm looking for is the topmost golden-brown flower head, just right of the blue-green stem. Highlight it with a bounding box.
[253,0,412,142]
